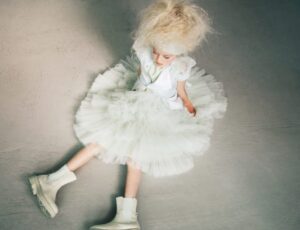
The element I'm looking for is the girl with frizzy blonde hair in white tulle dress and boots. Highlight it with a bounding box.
[29,0,226,230]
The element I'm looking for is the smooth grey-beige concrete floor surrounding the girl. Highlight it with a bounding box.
[0,0,300,230]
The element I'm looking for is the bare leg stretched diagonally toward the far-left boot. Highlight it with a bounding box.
[67,143,103,171]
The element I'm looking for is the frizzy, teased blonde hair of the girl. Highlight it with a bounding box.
[133,0,213,53]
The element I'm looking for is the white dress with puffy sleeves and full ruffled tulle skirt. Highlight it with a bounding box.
[73,42,227,177]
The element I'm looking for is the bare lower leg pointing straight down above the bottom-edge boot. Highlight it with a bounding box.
[125,161,142,198]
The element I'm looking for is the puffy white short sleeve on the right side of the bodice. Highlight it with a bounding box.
[171,56,196,81]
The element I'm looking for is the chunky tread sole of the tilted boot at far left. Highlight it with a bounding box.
[28,176,58,218]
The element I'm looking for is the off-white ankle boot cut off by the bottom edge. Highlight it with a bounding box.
[90,196,141,230]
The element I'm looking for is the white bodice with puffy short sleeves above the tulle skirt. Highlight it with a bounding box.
[132,42,196,109]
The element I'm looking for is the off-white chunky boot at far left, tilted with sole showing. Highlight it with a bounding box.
[28,165,77,218]
